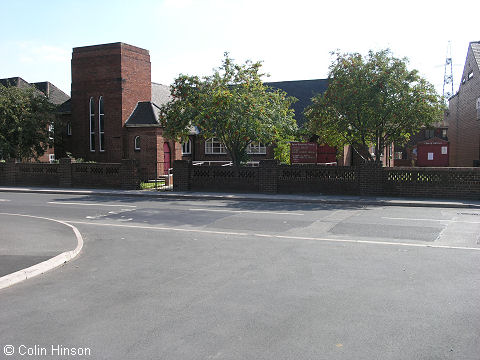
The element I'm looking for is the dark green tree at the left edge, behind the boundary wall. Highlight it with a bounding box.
[0,85,55,160]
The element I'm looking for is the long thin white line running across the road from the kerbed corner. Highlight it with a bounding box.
[70,221,480,251]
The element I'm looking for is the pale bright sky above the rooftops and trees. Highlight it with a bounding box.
[0,0,480,94]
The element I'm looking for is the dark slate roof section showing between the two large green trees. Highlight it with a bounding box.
[265,79,328,127]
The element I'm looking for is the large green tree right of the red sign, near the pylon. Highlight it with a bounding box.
[305,50,443,162]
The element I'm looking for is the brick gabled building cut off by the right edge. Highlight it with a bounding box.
[445,43,480,166]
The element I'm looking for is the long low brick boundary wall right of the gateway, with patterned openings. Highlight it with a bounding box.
[173,160,480,200]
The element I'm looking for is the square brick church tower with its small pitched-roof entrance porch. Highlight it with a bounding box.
[60,43,182,179]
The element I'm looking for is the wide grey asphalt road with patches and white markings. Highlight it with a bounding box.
[0,193,480,360]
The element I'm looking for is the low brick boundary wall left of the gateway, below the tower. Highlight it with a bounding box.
[0,159,140,189]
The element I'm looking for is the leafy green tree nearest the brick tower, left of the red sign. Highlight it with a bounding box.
[160,53,297,166]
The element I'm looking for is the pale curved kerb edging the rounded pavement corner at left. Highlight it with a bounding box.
[0,213,83,289]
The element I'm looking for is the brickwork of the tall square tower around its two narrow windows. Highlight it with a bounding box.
[70,43,151,162]
